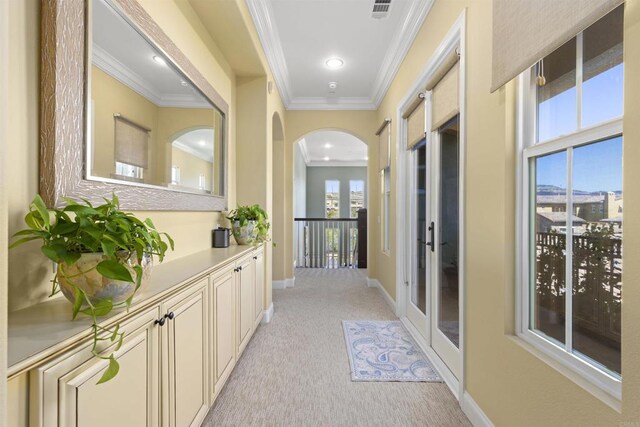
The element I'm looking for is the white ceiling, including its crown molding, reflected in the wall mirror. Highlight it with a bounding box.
[91,0,212,108]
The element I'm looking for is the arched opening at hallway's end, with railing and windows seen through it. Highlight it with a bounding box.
[293,129,369,268]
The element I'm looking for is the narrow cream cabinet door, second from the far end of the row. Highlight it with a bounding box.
[236,256,255,356]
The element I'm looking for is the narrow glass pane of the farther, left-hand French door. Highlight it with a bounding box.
[411,144,429,314]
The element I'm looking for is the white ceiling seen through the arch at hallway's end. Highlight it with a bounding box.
[298,131,367,166]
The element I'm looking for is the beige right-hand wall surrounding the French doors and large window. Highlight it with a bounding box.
[378,0,640,426]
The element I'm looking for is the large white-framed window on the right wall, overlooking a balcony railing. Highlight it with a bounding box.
[518,6,623,398]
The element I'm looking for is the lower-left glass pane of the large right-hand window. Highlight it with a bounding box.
[530,151,567,343]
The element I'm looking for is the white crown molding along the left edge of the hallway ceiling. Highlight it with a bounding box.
[246,0,291,108]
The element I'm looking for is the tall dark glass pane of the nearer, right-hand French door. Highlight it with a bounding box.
[438,118,460,347]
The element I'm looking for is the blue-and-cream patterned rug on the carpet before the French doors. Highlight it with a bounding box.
[342,320,442,382]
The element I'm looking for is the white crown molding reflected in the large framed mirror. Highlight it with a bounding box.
[91,44,213,109]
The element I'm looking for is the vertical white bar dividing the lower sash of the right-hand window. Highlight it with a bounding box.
[564,148,573,353]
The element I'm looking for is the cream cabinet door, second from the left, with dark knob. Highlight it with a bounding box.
[161,279,210,427]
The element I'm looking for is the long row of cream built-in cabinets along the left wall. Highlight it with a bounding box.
[18,247,265,427]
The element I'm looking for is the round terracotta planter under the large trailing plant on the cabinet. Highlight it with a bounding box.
[56,252,153,304]
